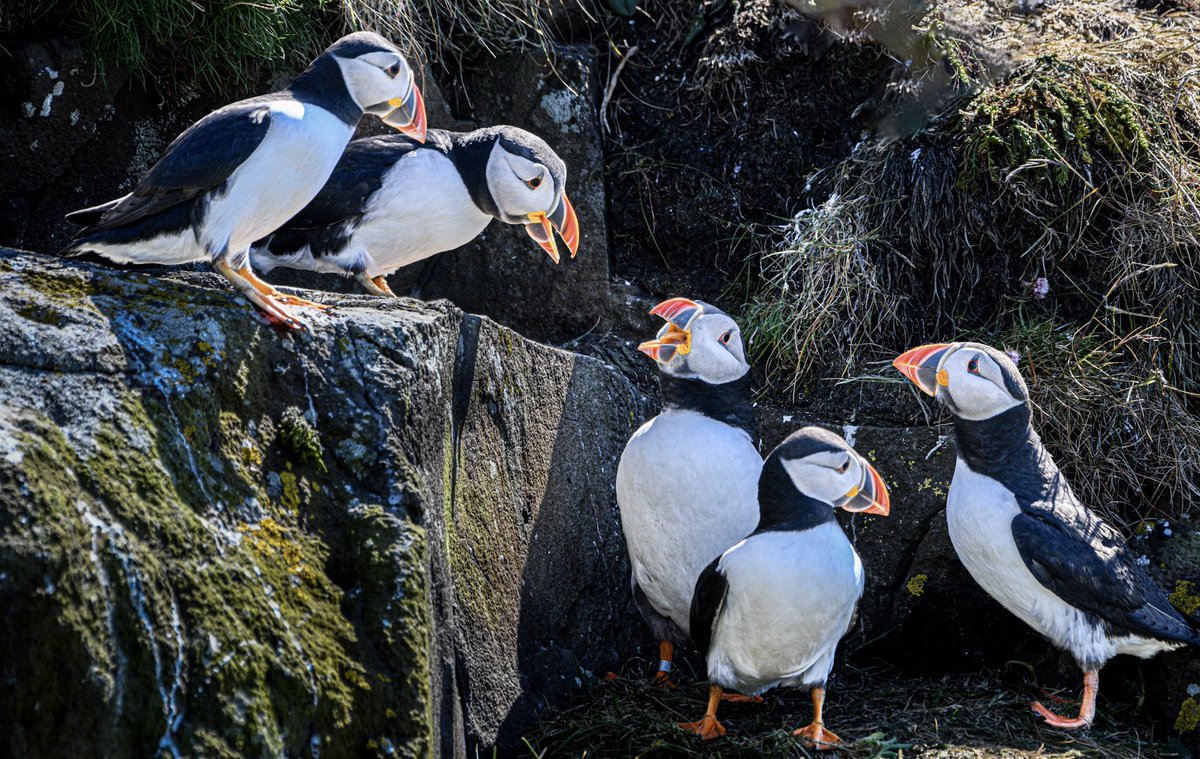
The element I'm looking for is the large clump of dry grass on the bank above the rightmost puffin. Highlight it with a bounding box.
[745,1,1200,522]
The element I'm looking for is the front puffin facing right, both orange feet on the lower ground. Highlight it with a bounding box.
[679,426,892,751]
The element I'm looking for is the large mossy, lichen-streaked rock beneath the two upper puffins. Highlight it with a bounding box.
[0,251,649,757]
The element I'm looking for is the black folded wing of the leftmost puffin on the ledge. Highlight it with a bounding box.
[67,98,271,237]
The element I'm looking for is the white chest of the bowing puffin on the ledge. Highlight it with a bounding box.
[347,150,492,276]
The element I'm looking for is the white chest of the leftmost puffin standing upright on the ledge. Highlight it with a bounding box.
[198,100,354,251]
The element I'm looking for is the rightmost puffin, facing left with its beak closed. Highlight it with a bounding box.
[893,342,1200,729]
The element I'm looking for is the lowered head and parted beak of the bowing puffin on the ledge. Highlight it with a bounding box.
[472,126,580,263]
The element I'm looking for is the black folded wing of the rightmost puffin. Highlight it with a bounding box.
[1012,504,1200,645]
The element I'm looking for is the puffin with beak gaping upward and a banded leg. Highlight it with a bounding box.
[617,298,762,686]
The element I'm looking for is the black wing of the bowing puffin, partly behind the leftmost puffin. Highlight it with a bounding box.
[254,135,421,256]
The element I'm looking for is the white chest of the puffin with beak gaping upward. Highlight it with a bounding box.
[617,411,762,633]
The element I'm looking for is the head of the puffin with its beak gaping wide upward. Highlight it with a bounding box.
[637,298,750,384]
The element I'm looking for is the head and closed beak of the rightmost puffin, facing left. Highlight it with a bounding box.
[892,342,1030,422]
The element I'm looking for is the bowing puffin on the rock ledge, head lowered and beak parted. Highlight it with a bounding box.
[251,126,580,297]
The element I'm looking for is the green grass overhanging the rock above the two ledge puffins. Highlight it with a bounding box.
[0,0,550,92]
